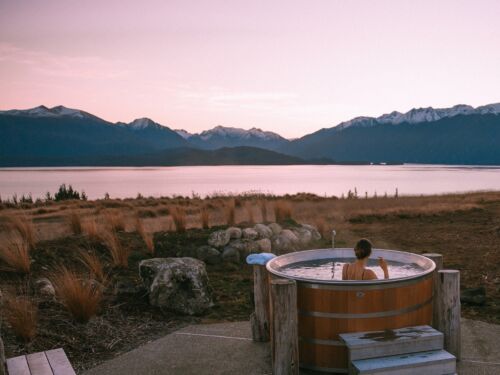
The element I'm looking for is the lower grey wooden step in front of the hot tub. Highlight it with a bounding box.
[351,350,456,375]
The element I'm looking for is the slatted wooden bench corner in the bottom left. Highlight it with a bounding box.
[7,348,76,375]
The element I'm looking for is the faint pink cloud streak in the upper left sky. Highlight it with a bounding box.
[0,42,129,79]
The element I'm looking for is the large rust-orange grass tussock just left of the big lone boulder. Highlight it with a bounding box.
[49,266,104,323]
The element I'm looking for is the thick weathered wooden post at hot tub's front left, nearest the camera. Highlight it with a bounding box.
[271,279,299,375]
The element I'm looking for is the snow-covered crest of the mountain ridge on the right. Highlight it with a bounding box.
[334,103,500,130]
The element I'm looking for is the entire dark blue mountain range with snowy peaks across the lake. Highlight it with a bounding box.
[0,103,500,166]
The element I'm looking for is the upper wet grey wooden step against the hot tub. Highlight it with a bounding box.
[340,326,443,361]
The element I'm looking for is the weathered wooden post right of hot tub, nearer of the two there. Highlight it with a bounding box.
[436,270,461,360]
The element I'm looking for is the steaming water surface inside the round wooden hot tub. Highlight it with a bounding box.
[279,258,424,280]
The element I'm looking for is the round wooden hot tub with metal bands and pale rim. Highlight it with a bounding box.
[267,249,435,373]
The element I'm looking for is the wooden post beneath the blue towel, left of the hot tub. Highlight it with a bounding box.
[250,265,270,342]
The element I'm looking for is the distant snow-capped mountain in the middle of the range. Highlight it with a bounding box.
[176,126,289,150]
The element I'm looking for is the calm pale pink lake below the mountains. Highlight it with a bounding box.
[0,165,500,199]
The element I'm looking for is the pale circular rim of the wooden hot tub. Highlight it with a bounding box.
[266,248,436,289]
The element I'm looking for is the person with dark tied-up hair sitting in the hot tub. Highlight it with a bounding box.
[342,238,389,280]
